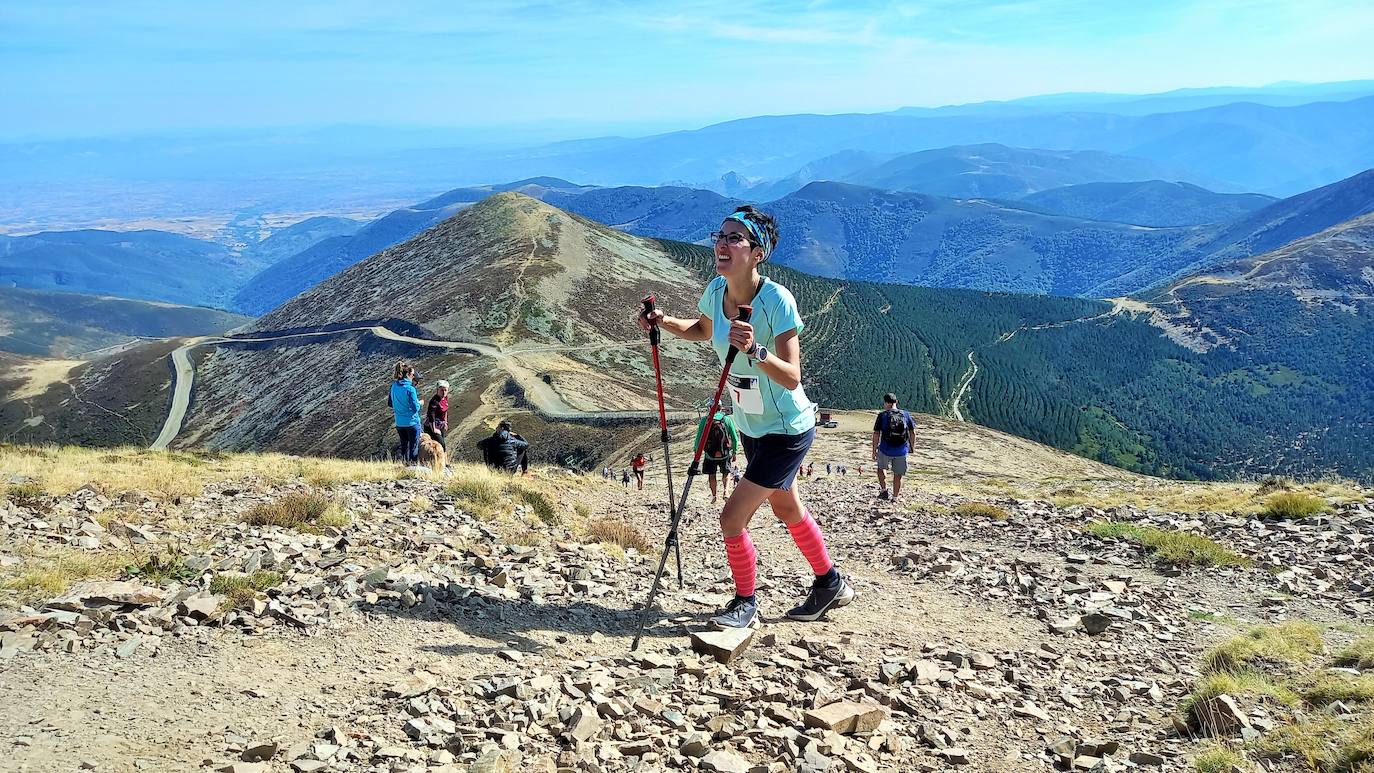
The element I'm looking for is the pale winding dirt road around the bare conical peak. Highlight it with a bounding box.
[148,325,688,450]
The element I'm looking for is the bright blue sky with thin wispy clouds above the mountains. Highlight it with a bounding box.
[0,0,1374,137]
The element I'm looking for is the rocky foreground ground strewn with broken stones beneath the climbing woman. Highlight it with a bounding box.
[0,434,1374,773]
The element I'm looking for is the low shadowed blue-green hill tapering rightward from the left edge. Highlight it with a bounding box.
[0,287,251,357]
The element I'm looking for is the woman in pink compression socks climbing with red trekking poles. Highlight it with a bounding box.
[639,205,855,627]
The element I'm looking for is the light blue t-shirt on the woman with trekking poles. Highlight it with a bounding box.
[697,276,816,438]
